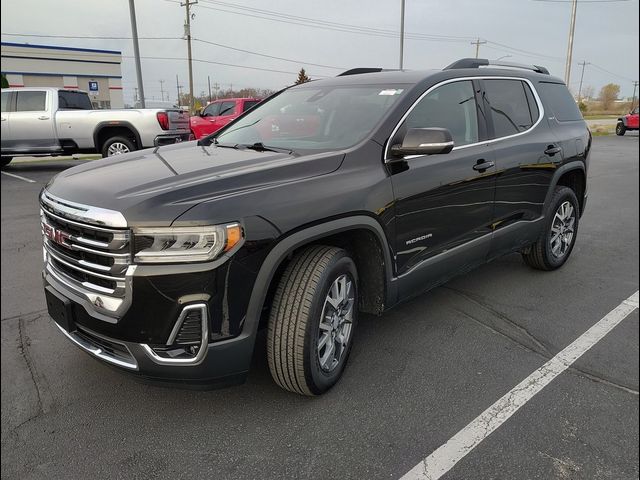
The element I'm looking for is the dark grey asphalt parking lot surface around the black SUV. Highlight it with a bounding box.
[1,134,639,480]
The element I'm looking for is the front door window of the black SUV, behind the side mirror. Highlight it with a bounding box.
[403,80,478,146]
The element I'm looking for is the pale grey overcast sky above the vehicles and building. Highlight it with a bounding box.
[0,0,639,102]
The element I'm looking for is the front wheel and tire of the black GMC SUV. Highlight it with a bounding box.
[267,245,358,396]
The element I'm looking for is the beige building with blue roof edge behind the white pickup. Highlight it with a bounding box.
[1,42,124,108]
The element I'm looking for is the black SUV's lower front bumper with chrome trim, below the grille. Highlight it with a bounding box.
[43,262,255,388]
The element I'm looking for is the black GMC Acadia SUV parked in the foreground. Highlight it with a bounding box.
[40,59,591,395]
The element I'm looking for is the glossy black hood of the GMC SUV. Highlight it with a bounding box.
[45,142,344,226]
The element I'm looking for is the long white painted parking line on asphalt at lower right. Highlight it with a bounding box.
[401,292,638,480]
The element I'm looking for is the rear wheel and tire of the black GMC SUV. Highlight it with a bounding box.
[522,186,580,270]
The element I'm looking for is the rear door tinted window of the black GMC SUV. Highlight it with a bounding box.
[484,80,538,138]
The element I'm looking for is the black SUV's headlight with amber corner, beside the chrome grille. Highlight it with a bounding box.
[133,223,243,263]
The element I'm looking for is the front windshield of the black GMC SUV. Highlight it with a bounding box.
[216,85,404,151]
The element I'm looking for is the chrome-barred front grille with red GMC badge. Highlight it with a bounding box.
[41,196,131,298]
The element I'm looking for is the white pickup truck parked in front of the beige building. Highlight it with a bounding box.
[1,88,191,166]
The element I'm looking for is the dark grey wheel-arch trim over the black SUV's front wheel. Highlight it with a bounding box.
[241,215,396,336]
